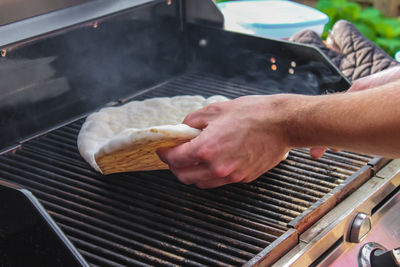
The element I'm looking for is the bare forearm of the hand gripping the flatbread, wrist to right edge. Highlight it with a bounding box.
[288,81,400,157]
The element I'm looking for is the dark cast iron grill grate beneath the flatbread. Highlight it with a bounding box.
[0,73,372,266]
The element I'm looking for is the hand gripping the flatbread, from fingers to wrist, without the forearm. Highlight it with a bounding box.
[158,95,290,188]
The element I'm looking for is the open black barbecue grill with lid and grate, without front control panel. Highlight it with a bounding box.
[0,0,394,266]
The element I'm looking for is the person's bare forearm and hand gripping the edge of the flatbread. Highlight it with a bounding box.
[159,79,400,188]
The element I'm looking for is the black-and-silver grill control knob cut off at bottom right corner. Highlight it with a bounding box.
[358,242,400,267]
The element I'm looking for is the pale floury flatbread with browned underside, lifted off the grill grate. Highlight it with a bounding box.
[78,96,229,174]
